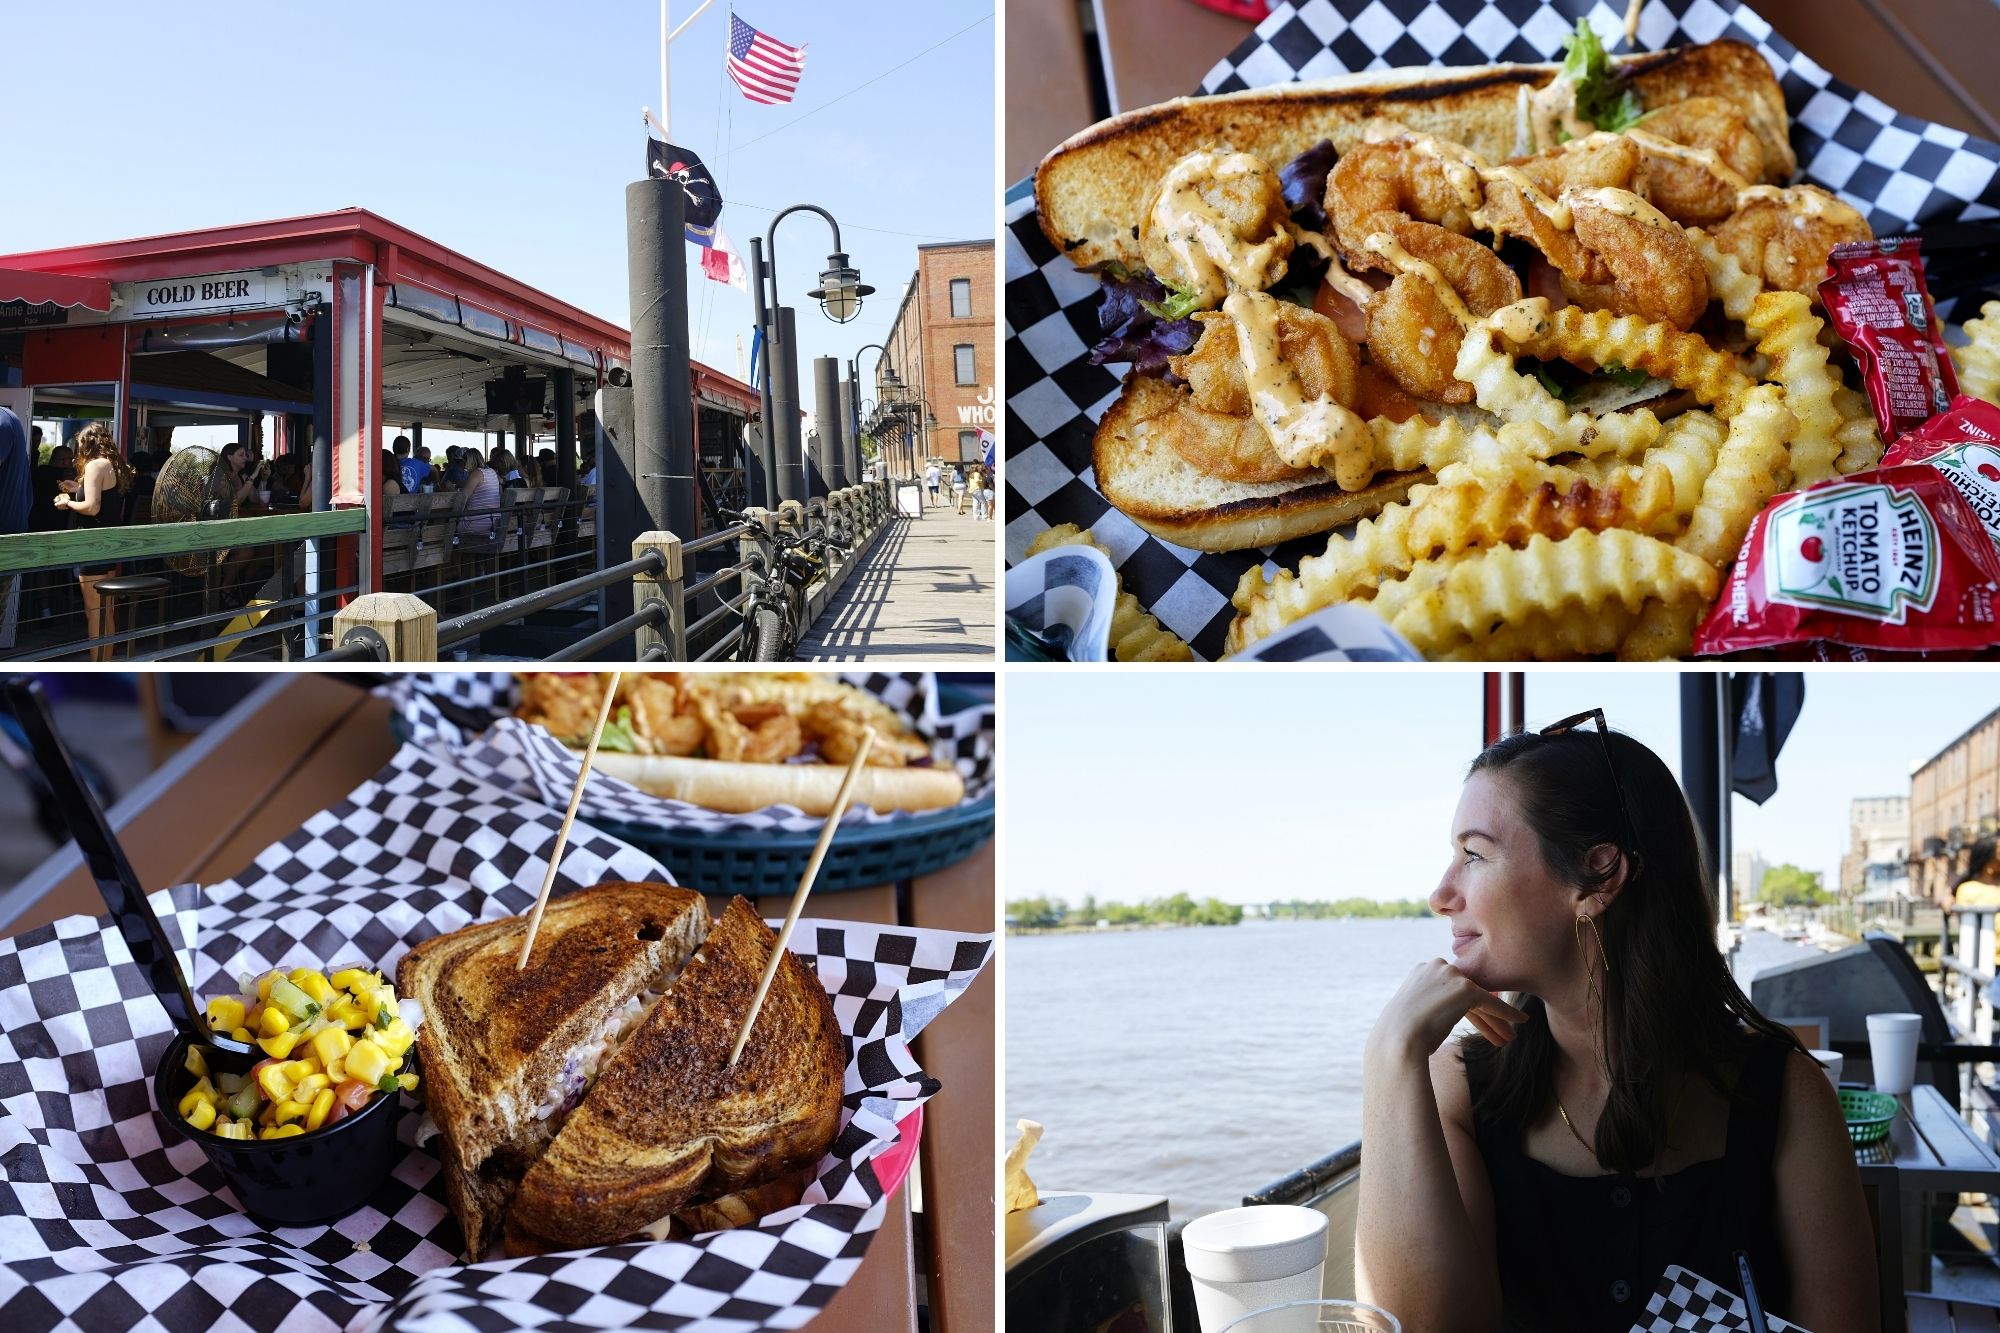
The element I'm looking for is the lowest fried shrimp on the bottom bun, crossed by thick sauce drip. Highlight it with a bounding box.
[1148,300,1360,482]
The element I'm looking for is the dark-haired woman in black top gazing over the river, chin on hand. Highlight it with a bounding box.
[1356,713,1878,1333]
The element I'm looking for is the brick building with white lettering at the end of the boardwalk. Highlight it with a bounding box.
[870,240,1000,476]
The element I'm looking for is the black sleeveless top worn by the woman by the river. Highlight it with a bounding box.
[1466,1037,1792,1333]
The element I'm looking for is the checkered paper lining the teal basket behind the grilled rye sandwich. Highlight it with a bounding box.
[380,671,996,833]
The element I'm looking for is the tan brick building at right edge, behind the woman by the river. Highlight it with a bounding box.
[1910,709,2000,907]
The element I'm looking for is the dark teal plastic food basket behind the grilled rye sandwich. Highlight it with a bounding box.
[390,673,994,899]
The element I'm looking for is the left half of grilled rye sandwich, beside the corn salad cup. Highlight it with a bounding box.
[396,885,708,1259]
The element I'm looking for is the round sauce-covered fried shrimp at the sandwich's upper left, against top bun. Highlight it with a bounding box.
[1140,152,1292,308]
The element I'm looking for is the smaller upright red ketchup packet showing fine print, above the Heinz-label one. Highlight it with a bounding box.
[1820,236,1958,440]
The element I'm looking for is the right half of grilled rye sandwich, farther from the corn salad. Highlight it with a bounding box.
[504,899,846,1255]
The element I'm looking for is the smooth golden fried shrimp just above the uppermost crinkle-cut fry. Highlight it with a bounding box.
[1558,188,1708,328]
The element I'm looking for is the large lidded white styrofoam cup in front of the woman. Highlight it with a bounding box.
[1180,1203,1326,1333]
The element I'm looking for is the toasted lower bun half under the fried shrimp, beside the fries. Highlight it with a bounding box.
[1092,374,1430,550]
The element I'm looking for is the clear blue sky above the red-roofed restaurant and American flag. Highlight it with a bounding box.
[0,0,996,400]
